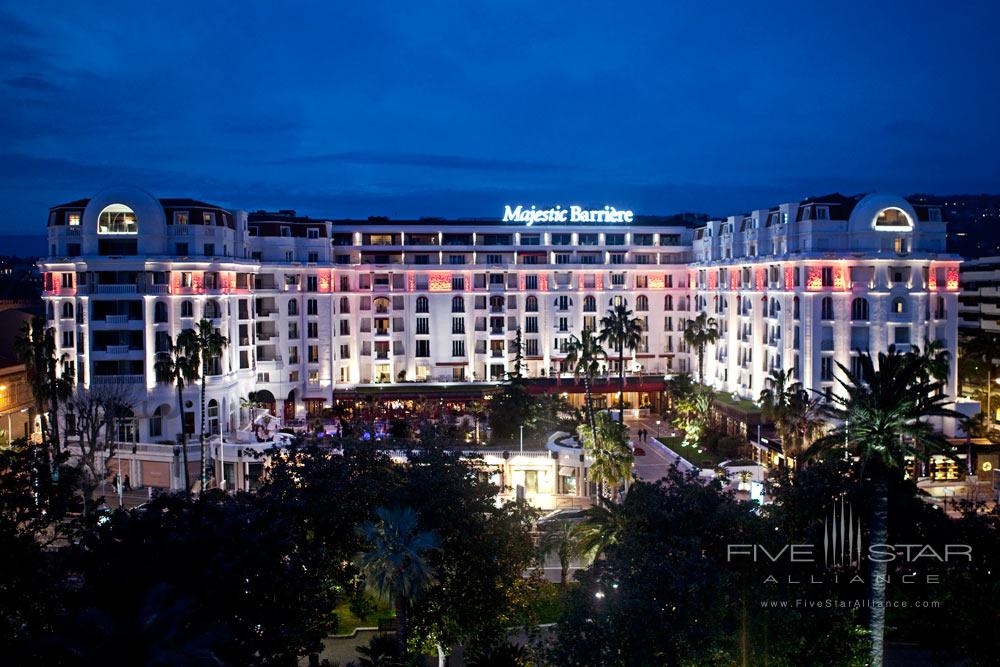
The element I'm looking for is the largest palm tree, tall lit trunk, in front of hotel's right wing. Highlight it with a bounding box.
[806,346,960,667]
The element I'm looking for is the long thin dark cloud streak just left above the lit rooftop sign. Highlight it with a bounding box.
[269,151,569,172]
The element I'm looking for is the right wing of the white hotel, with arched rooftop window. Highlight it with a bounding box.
[691,194,960,430]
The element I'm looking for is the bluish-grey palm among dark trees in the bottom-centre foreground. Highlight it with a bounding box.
[358,507,438,656]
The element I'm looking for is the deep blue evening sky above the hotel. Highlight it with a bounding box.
[0,0,1000,232]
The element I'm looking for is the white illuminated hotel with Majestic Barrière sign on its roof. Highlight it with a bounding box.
[40,188,959,483]
